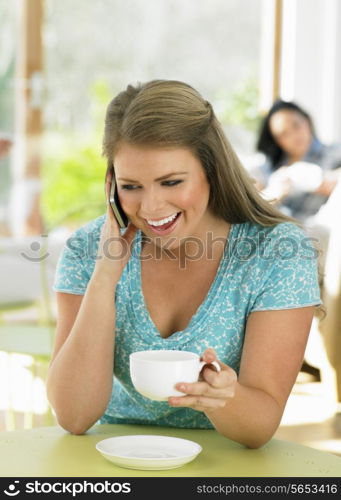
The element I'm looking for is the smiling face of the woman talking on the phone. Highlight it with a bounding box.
[113,144,213,248]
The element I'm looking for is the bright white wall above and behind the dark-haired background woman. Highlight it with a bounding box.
[280,0,341,143]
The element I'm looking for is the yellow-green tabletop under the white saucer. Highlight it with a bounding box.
[0,425,341,477]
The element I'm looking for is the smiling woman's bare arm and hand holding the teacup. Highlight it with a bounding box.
[170,307,314,448]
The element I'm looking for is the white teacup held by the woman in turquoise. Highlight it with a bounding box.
[130,350,220,401]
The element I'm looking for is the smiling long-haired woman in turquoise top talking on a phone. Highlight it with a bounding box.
[47,80,320,448]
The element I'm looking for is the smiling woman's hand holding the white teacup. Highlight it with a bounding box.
[168,349,237,412]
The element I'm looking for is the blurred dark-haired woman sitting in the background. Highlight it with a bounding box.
[253,99,341,224]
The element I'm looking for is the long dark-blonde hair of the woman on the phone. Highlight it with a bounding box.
[103,80,297,226]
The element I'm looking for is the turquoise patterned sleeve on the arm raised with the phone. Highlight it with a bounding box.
[52,229,96,295]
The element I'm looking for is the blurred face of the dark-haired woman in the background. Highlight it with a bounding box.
[269,110,312,160]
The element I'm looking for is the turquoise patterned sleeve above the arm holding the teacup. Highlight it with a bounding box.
[250,223,322,312]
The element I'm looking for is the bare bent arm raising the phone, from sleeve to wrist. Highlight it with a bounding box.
[47,276,115,434]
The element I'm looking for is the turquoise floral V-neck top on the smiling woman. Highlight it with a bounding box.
[53,215,321,429]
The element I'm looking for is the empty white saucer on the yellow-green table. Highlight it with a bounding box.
[96,435,202,470]
